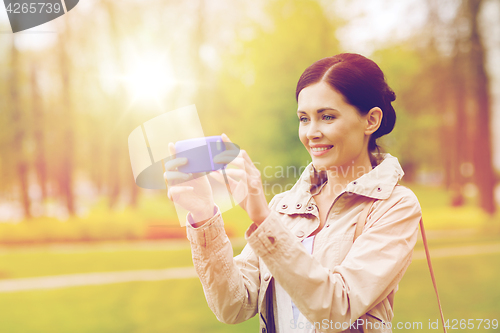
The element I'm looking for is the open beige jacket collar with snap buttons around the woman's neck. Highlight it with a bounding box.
[276,154,404,214]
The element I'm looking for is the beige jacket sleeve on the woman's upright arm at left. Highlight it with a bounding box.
[186,198,284,324]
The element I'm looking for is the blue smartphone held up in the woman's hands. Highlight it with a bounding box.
[175,135,227,173]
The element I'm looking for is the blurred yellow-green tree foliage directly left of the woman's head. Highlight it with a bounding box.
[213,0,339,181]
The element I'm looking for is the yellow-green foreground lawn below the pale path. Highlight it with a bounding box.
[0,250,500,333]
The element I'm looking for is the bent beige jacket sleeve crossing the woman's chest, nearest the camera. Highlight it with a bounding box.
[245,190,421,332]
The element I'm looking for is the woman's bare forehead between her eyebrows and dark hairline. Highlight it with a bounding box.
[298,82,352,111]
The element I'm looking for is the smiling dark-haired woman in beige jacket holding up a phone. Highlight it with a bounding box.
[165,53,421,333]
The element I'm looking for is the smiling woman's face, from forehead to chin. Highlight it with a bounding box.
[297,82,370,172]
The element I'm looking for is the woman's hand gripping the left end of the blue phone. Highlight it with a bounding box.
[163,142,215,222]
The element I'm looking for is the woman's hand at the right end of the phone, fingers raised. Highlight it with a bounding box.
[210,134,270,225]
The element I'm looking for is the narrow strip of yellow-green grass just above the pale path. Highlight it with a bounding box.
[0,233,500,279]
